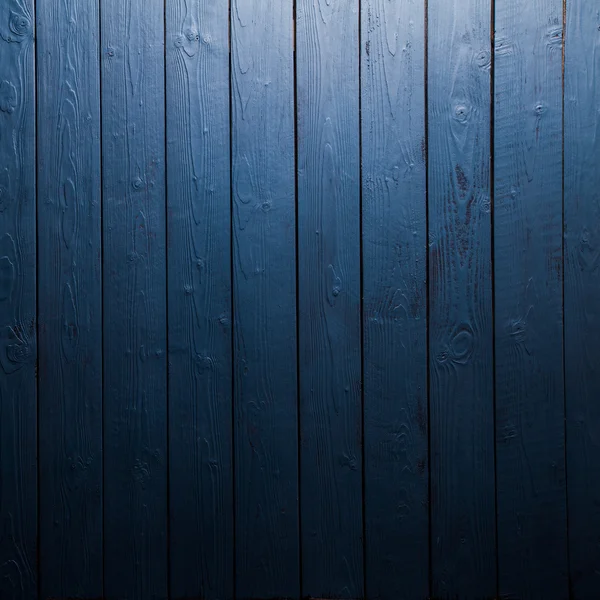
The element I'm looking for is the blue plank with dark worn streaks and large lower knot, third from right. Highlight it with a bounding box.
[428,0,496,600]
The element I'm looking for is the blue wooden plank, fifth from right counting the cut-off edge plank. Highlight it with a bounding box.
[296,0,364,598]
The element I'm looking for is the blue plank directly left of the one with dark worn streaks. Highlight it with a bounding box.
[361,0,429,600]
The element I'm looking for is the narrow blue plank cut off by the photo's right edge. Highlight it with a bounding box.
[564,0,600,600]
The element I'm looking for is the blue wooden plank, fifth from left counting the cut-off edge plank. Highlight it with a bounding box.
[231,0,300,600]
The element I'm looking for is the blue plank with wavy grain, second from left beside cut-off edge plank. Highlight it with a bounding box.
[36,0,102,598]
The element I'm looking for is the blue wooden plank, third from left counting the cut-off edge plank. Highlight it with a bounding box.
[101,0,167,600]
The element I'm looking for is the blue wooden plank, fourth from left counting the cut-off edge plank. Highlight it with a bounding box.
[167,0,233,600]
